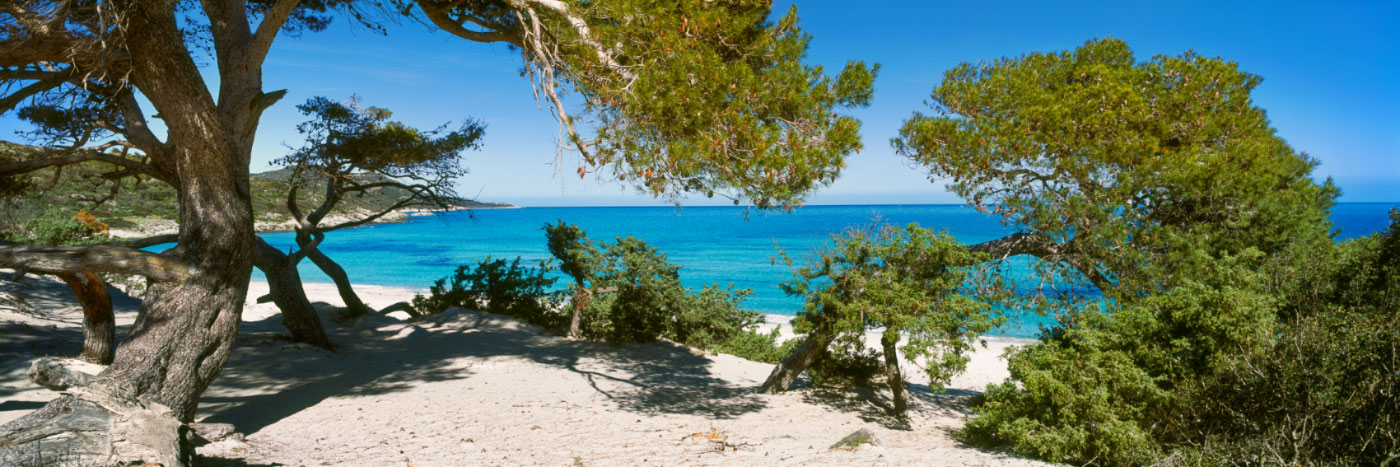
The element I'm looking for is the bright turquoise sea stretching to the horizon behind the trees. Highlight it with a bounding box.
[253,203,1396,337]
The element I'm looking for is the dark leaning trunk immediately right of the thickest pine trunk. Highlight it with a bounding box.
[253,238,335,350]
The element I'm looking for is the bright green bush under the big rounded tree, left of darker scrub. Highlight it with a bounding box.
[963,250,1277,464]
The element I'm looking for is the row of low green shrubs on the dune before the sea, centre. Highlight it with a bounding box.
[413,222,792,362]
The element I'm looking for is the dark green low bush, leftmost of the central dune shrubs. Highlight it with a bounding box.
[413,257,563,327]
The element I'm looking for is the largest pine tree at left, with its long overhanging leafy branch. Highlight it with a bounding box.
[0,0,875,464]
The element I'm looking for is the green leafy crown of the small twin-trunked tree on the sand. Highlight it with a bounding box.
[783,224,1005,402]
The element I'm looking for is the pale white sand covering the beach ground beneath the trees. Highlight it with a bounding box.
[0,275,1033,466]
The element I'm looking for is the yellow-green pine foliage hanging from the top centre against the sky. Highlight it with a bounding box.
[526,0,878,207]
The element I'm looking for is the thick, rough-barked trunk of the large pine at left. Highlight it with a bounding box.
[0,0,262,466]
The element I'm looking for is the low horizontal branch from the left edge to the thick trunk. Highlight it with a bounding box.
[0,242,190,281]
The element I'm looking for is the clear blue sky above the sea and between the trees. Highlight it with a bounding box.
[0,0,1400,206]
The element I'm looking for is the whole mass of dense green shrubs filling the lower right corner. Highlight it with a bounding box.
[962,213,1400,464]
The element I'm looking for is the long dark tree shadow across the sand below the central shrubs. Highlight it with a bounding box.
[200,303,766,433]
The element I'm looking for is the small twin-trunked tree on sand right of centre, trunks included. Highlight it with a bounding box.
[762,224,1001,415]
